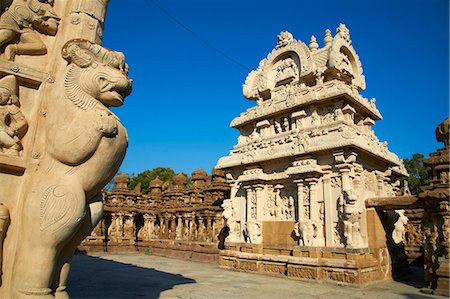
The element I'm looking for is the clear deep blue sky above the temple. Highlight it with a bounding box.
[103,0,449,174]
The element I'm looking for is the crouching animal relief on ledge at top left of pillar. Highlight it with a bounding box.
[0,0,60,61]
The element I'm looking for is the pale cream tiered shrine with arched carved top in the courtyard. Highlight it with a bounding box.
[216,24,407,284]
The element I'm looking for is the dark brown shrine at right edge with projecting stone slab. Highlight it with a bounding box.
[366,118,450,297]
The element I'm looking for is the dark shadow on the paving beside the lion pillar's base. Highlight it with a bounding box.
[68,254,196,299]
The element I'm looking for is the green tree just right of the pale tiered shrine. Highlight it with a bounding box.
[403,153,430,195]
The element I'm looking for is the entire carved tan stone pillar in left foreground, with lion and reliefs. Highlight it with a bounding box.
[0,0,131,298]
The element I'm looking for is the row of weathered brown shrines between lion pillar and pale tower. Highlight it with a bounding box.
[80,170,230,261]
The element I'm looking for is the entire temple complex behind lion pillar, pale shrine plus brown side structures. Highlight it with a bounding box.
[79,24,450,296]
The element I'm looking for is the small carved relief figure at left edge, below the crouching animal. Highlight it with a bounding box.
[0,75,27,156]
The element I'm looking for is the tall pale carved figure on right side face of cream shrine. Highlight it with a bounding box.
[340,190,363,248]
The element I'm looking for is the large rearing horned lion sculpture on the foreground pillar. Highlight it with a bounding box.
[7,40,131,298]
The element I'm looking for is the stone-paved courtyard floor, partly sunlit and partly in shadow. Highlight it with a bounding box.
[68,253,444,299]
